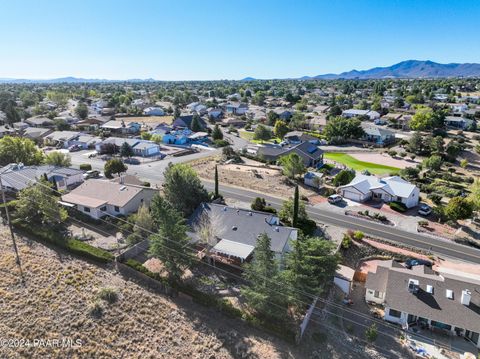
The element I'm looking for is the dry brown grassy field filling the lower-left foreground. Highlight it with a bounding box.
[0,227,382,358]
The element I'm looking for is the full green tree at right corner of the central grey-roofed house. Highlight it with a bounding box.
[283,236,340,307]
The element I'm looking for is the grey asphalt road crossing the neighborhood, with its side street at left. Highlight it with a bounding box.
[71,146,480,263]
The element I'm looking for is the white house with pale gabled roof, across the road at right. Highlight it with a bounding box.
[339,175,420,208]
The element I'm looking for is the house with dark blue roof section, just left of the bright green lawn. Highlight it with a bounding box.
[256,142,323,168]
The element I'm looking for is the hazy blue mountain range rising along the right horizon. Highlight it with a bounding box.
[243,60,480,81]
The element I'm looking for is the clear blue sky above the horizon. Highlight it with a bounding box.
[0,0,480,80]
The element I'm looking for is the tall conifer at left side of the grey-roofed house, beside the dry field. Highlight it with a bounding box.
[149,195,194,282]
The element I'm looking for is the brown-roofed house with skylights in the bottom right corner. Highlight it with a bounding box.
[365,260,480,348]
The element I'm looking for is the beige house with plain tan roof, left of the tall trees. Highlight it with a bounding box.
[62,179,157,219]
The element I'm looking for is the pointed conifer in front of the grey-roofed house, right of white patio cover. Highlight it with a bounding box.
[241,233,287,318]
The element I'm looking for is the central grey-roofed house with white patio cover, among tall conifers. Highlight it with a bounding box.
[189,203,297,263]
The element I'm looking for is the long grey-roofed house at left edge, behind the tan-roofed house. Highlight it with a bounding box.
[0,163,83,193]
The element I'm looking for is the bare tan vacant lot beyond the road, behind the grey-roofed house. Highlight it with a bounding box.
[190,157,316,198]
